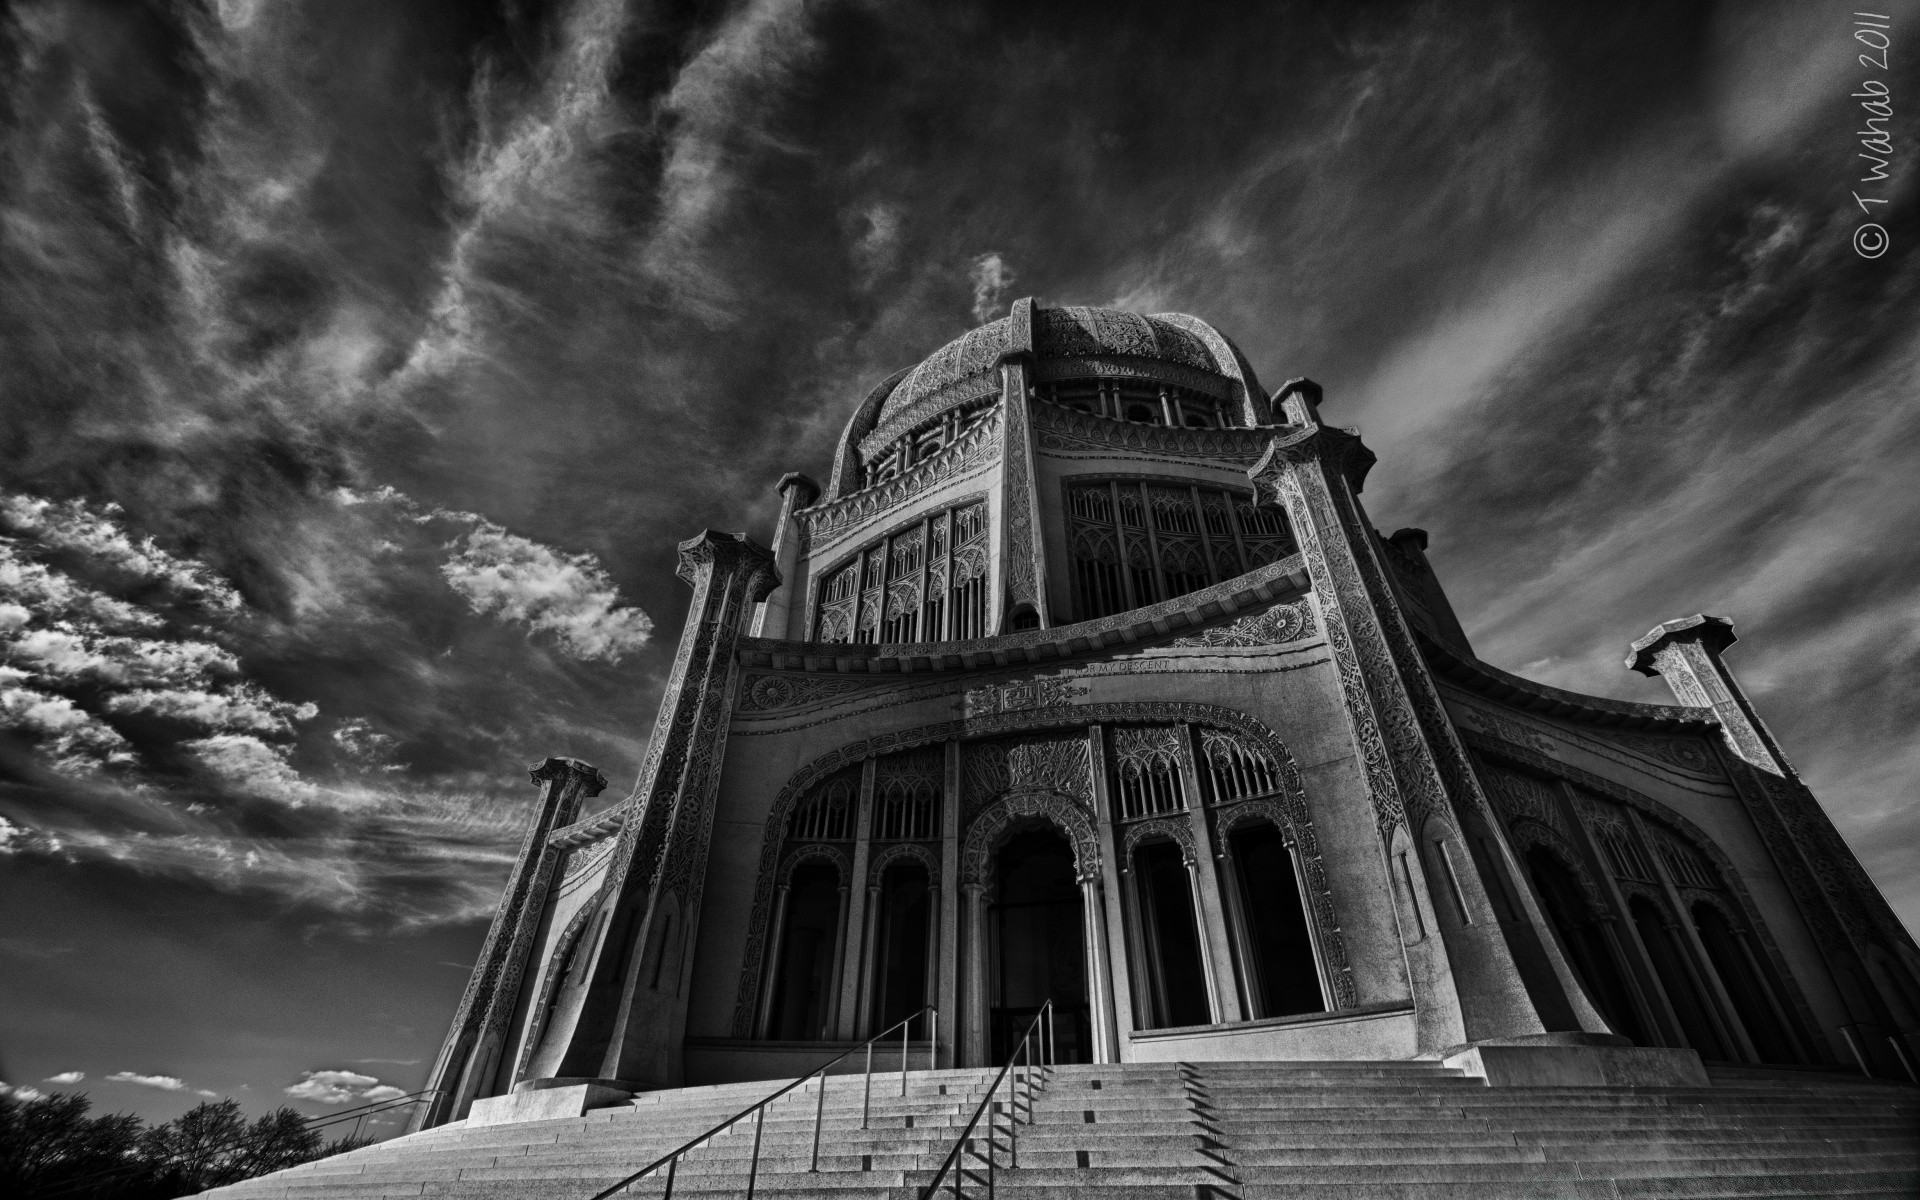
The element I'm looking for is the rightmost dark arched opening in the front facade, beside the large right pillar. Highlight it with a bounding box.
[1227,824,1327,1018]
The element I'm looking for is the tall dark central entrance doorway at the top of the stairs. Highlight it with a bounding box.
[987,828,1092,1064]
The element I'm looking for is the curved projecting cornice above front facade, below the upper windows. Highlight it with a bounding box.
[737,555,1308,674]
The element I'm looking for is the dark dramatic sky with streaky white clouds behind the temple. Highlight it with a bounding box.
[0,0,1920,1133]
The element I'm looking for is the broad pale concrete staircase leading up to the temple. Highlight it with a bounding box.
[207,1062,1920,1200]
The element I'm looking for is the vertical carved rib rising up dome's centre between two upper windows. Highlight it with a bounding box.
[987,298,1054,636]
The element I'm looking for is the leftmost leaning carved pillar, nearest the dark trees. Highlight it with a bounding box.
[409,758,607,1131]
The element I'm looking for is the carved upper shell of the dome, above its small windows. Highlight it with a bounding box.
[876,305,1233,424]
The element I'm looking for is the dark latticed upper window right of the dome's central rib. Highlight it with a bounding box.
[1066,480,1296,620]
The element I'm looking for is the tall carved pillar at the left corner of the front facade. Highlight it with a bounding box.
[529,530,780,1089]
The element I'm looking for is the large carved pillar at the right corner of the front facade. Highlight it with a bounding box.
[1248,380,1565,1050]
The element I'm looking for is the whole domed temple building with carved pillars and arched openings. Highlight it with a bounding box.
[417,300,1920,1127]
